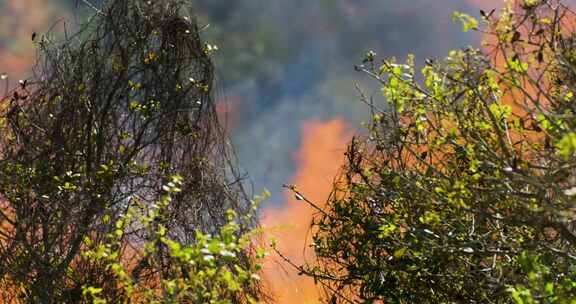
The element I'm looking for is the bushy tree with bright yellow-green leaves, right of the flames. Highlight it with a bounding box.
[301,0,576,303]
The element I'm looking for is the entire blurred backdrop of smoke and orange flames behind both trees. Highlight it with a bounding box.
[0,0,501,303]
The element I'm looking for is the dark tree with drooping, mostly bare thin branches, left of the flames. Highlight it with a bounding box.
[0,0,255,303]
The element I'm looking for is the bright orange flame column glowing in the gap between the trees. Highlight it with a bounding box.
[262,119,352,304]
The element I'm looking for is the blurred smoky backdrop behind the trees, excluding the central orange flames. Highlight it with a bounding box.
[0,0,477,203]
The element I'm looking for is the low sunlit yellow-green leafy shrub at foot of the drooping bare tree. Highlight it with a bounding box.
[82,175,265,304]
